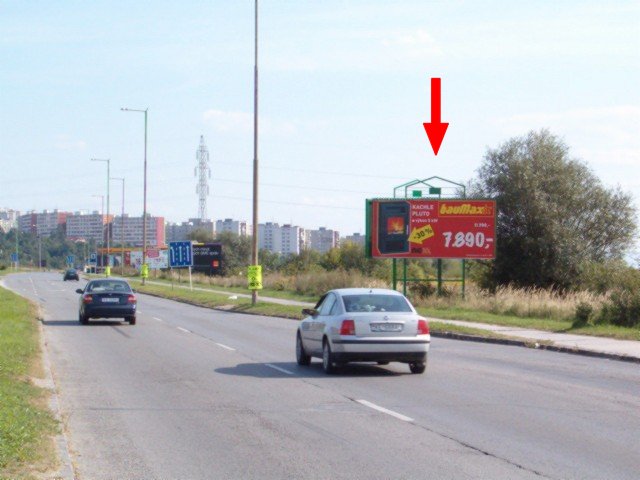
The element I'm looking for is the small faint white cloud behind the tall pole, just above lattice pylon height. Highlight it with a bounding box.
[202,109,296,136]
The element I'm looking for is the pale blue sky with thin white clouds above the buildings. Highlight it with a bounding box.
[0,0,640,255]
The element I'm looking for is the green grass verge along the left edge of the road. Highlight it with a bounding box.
[0,288,57,478]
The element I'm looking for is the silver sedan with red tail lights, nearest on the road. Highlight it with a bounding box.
[296,288,431,373]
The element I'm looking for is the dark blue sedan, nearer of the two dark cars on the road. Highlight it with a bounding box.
[76,278,137,325]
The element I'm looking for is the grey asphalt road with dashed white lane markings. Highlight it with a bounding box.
[4,273,640,480]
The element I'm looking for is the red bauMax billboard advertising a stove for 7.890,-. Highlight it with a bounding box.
[367,199,496,259]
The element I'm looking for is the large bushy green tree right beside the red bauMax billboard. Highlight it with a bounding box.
[471,130,636,289]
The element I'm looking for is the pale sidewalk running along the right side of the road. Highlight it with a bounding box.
[136,280,640,363]
